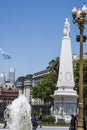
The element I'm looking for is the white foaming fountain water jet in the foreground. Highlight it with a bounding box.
[4,94,32,130]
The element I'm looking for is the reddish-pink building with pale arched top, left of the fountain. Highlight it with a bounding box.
[0,83,19,120]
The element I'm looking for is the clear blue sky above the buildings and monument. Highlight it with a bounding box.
[0,0,87,78]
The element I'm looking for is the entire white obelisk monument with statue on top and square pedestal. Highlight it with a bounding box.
[52,18,77,122]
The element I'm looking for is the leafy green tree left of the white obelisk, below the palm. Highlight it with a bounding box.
[32,72,57,103]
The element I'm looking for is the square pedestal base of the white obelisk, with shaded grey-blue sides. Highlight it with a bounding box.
[52,89,77,123]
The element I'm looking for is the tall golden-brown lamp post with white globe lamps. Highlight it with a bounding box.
[72,5,87,130]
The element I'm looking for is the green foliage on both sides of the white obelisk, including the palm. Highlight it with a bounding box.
[32,58,87,103]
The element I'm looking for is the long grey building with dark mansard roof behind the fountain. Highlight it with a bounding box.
[16,68,50,104]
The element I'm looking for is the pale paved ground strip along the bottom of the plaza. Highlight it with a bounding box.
[0,124,69,130]
